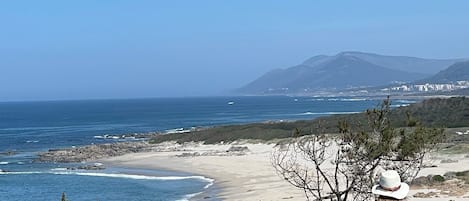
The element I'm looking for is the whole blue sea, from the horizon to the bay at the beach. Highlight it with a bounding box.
[0,96,409,201]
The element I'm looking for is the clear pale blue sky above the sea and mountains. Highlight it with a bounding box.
[0,0,469,101]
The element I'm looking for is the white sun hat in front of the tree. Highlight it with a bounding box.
[371,170,409,200]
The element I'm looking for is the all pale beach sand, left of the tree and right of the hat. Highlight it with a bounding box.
[100,143,469,201]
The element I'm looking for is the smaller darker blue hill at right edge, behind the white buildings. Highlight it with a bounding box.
[418,61,469,84]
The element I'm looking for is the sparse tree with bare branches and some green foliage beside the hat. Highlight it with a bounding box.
[272,98,444,200]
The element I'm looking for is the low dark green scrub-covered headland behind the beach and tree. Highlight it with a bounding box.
[151,97,469,144]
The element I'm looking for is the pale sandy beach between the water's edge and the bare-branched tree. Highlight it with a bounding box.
[98,144,304,201]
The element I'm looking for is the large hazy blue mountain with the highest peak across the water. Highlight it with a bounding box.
[238,52,464,94]
